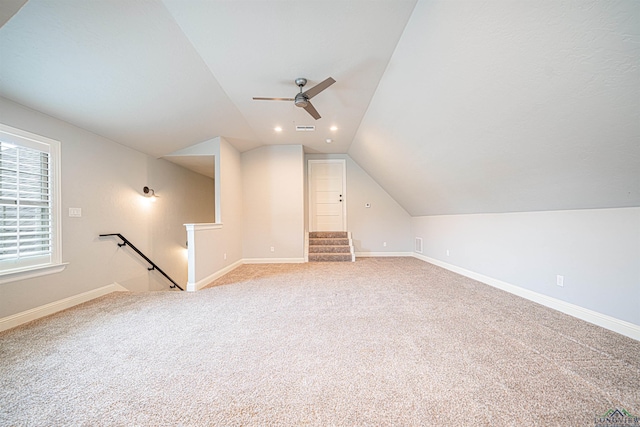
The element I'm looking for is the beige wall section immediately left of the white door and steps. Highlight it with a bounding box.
[244,145,304,262]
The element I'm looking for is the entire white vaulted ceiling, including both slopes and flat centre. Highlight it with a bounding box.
[0,0,640,215]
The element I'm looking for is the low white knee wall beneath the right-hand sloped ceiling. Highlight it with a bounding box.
[412,208,640,325]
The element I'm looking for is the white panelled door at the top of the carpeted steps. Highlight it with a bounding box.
[309,159,347,231]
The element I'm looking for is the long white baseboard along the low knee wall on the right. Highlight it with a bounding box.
[412,253,640,341]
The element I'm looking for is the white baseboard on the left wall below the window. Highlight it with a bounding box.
[0,283,127,332]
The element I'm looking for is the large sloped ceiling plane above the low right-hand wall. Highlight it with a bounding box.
[349,0,640,216]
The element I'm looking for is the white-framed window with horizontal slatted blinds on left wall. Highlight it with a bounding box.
[0,125,64,283]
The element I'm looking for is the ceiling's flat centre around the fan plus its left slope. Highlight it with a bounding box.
[0,0,415,157]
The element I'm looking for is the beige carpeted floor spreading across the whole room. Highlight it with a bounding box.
[0,258,640,427]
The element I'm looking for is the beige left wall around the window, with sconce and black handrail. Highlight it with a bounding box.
[0,98,213,318]
